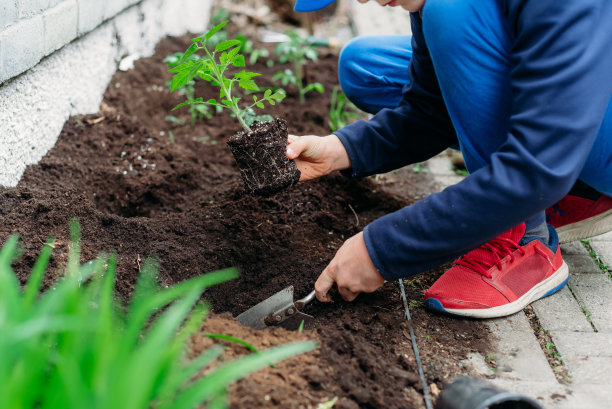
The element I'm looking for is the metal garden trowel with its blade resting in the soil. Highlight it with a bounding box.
[236,286,315,330]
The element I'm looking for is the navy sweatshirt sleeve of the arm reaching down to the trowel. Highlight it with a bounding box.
[364,0,612,279]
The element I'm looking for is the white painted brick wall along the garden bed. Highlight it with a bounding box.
[0,0,212,187]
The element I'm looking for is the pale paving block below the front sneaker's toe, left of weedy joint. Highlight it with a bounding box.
[487,312,556,384]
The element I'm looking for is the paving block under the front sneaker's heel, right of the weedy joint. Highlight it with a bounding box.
[531,286,593,333]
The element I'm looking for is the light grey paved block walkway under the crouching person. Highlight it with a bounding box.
[345,0,612,409]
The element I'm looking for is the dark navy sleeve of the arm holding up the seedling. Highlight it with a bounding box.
[335,14,457,177]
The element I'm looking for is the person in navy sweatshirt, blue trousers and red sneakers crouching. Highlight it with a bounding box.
[287,0,612,318]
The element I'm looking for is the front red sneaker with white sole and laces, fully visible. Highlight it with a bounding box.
[425,223,569,318]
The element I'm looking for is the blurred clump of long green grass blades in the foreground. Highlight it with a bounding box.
[0,221,315,409]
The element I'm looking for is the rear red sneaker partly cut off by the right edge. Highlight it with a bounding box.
[546,195,612,243]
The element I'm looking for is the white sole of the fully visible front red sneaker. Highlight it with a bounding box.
[444,261,569,318]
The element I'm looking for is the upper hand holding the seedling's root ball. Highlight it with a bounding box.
[287,135,351,181]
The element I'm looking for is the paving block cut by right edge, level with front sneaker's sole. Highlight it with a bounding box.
[569,274,612,334]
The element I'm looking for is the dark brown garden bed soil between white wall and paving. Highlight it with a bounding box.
[0,29,487,409]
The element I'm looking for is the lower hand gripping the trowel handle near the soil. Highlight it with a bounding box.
[315,232,385,302]
